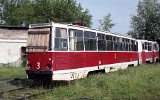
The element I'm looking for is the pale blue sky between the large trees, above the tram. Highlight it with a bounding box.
[77,0,139,34]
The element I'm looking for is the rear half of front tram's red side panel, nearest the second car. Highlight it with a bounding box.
[99,51,138,67]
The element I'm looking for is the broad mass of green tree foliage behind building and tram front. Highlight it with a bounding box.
[0,0,92,26]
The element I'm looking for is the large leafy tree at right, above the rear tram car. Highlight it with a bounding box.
[128,0,160,40]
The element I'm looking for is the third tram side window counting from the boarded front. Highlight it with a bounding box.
[84,31,97,51]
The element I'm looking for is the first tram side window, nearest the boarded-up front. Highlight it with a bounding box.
[55,27,68,51]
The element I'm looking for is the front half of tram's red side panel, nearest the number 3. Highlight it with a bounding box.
[55,52,98,71]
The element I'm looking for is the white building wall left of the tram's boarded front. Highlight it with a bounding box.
[0,39,27,64]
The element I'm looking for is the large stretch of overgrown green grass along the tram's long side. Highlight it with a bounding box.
[36,64,160,100]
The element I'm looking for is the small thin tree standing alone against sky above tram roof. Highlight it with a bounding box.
[99,13,115,31]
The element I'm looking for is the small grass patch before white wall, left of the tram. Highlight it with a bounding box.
[0,65,26,80]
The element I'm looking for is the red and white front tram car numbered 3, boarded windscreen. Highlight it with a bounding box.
[26,22,157,81]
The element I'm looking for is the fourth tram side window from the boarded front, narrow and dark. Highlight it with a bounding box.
[97,33,106,51]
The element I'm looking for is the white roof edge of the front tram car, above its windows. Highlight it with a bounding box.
[29,22,136,40]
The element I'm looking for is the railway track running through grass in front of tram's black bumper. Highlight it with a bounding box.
[0,79,52,100]
